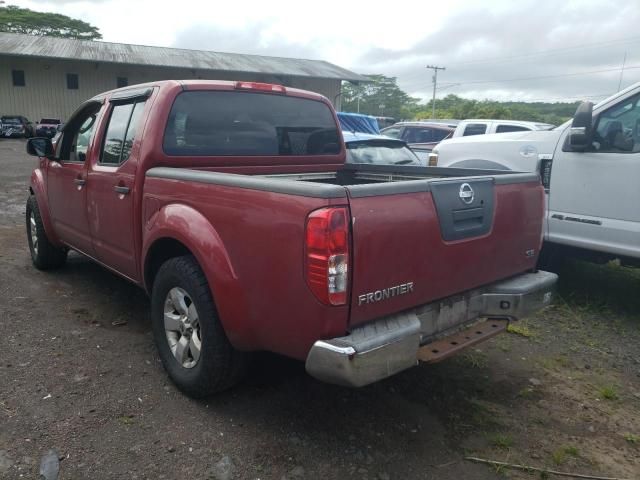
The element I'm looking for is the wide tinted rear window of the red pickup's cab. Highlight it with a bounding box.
[163,91,341,156]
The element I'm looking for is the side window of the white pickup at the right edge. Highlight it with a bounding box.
[593,95,640,153]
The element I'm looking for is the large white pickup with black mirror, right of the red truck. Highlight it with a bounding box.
[429,83,640,265]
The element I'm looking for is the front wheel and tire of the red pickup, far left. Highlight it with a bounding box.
[26,195,67,270]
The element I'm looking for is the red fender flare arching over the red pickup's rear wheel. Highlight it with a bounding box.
[141,203,250,348]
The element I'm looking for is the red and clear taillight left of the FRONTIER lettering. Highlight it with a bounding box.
[305,207,349,305]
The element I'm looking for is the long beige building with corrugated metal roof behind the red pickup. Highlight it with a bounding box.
[0,33,367,121]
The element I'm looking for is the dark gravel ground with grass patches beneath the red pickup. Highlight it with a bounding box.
[0,139,640,480]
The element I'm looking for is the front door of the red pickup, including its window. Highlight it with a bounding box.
[47,103,101,257]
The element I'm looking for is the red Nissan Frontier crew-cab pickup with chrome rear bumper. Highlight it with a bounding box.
[26,80,556,396]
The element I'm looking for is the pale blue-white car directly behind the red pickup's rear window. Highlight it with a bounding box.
[342,131,426,166]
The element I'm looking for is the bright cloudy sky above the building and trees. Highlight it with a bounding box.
[11,0,640,101]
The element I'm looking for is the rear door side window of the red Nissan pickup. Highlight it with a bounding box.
[100,101,144,166]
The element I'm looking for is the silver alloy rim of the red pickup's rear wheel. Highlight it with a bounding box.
[164,287,202,368]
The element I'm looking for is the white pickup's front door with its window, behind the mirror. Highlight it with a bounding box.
[548,94,640,256]
